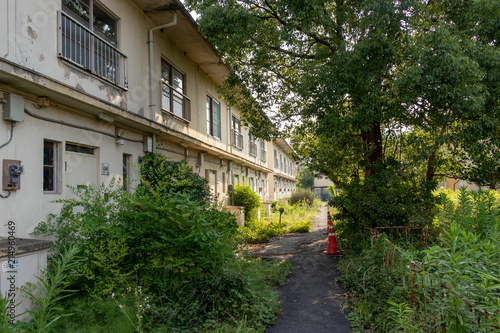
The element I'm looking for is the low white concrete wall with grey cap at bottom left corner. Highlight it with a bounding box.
[0,236,52,322]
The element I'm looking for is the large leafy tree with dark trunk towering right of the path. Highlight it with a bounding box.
[187,0,500,232]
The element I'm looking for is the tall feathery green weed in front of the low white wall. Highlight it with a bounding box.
[22,245,80,333]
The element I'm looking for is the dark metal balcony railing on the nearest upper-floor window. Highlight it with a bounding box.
[58,12,128,89]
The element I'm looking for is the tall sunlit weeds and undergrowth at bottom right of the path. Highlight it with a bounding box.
[339,189,500,332]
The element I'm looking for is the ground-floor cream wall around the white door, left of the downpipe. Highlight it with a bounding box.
[0,94,143,237]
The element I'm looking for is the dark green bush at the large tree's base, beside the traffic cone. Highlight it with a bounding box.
[329,169,439,248]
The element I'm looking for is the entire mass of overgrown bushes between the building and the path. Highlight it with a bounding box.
[28,156,289,331]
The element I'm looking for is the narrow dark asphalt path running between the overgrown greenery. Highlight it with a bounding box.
[257,202,352,333]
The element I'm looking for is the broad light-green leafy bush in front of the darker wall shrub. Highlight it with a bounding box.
[36,180,236,297]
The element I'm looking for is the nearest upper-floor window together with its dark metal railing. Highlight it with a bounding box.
[59,0,128,88]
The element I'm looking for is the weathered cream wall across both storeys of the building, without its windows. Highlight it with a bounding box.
[0,0,278,237]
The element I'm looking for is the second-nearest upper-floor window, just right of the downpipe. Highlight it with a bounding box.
[161,59,191,121]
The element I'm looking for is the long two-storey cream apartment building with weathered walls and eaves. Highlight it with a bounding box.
[0,0,295,238]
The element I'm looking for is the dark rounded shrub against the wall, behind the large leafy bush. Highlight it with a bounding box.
[137,154,213,205]
